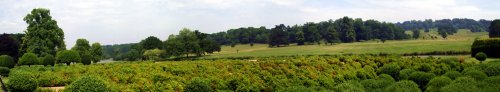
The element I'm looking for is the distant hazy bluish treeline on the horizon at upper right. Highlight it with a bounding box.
[396,18,491,32]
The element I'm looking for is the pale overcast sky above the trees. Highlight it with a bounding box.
[0,0,500,47]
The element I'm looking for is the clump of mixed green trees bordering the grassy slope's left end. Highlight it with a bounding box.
[103,28,221,61]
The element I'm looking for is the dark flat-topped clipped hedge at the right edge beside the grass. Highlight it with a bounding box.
[471,38,500,57]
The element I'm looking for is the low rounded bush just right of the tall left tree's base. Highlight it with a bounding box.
[56,50,81,65]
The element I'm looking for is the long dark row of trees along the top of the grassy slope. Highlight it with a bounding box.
[210,17,409,46]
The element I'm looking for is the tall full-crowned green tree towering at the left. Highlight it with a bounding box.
[20,8,66,56]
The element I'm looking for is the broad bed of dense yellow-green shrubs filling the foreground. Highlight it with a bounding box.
[7,55,500,92]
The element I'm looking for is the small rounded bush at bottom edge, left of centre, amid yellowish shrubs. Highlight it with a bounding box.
[184,78,212,92]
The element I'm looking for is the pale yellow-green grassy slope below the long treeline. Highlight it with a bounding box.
[207,30,488,58]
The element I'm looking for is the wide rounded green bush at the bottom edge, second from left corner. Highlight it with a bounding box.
[66,76,110,92]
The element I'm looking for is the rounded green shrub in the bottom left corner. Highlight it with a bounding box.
[7,73,38,92]
